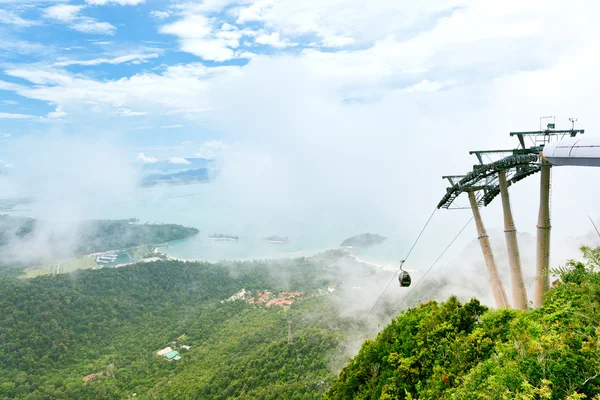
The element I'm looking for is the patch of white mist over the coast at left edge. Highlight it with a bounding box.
[0,133,139,264]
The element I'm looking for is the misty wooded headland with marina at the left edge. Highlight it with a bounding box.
[0,214,199,275]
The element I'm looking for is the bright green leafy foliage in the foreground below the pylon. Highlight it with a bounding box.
[325,247,600,400]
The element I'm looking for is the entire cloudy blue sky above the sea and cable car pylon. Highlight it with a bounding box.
[0,0,600,250]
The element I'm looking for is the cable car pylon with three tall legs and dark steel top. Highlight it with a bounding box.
[438,117,584,310]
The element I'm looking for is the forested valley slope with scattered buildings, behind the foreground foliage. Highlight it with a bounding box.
[0,258,361,399]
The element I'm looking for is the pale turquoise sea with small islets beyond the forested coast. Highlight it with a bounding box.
[11,184,407,264]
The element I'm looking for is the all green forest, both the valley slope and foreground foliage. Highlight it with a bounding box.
[0,242,600,400]
